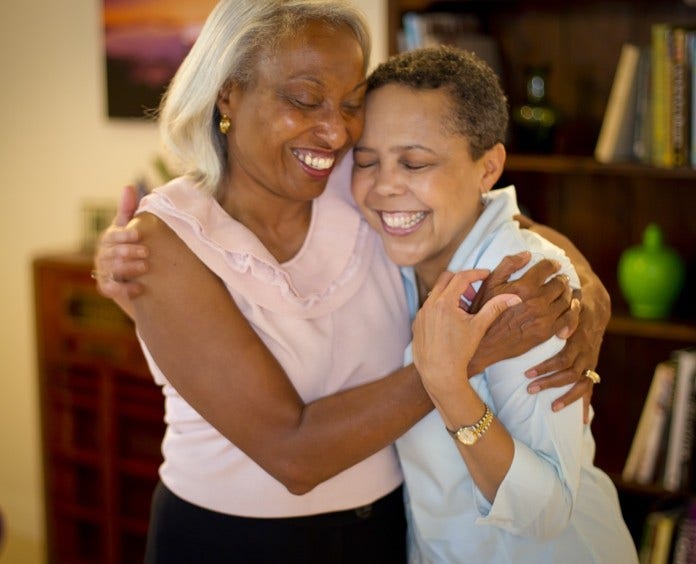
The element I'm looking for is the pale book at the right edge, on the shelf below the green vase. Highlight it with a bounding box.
[662,349,696,491]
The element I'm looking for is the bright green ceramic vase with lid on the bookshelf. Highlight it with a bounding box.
[618,223,684,319]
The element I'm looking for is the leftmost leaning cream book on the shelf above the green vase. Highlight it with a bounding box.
[595,43,640,163]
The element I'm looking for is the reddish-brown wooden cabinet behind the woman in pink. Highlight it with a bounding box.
[34,255,164,564]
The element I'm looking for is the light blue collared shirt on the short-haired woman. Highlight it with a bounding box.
[397,187,638,564]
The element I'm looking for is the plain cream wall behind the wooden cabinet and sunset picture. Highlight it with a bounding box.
[0,0,387,564]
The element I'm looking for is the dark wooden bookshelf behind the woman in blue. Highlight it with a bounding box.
[388,0,696,543]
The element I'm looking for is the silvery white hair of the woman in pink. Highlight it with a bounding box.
[159,0,371,194]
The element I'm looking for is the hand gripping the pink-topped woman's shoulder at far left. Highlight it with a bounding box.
[92,186,148,308]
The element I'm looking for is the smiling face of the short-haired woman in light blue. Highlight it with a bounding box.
[352,84,504,287]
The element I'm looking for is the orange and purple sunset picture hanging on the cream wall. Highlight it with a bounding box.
[103,0,216,118]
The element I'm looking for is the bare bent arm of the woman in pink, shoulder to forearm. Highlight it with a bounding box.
[133,214,432,494]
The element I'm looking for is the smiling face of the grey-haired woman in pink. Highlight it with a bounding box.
[218,22,365,208]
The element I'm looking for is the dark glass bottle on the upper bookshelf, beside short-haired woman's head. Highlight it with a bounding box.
[512,66,559,153]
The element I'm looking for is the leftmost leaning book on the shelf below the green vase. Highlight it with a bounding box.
[621,361,675,483]
